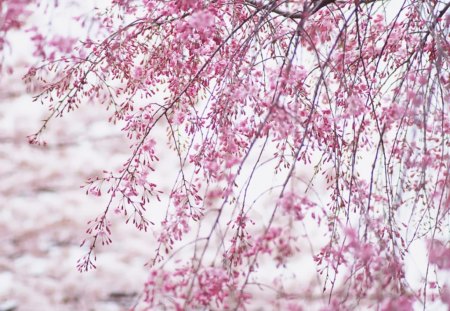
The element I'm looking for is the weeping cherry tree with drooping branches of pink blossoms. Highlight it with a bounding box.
[0,0,450,310]
